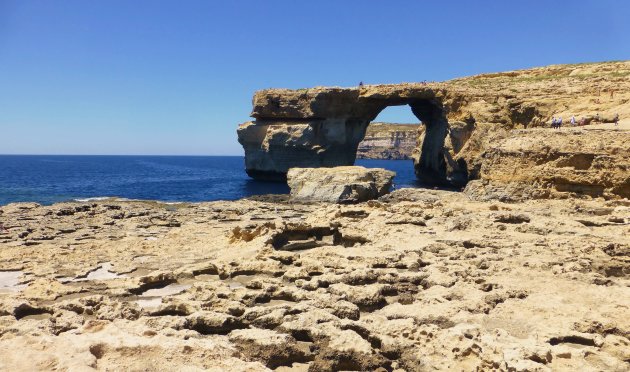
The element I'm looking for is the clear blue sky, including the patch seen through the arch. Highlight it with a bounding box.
[0,0,630,155]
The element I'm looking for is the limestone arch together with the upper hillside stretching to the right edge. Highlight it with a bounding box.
[238,61,630,189]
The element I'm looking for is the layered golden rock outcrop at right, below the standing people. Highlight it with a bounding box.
[465,129,630,201]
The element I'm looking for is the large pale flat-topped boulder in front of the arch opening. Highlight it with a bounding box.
[287,166,396,204]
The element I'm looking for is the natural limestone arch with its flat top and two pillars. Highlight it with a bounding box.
[238,85,472,184]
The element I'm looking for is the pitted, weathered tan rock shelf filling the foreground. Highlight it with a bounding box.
[0,195,630,371]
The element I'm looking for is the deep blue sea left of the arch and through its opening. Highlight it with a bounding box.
[0,155,424,205]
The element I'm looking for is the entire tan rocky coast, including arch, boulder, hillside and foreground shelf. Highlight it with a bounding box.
[0,62,630,372]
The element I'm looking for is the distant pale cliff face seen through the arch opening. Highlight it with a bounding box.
[357,123,424,160]
